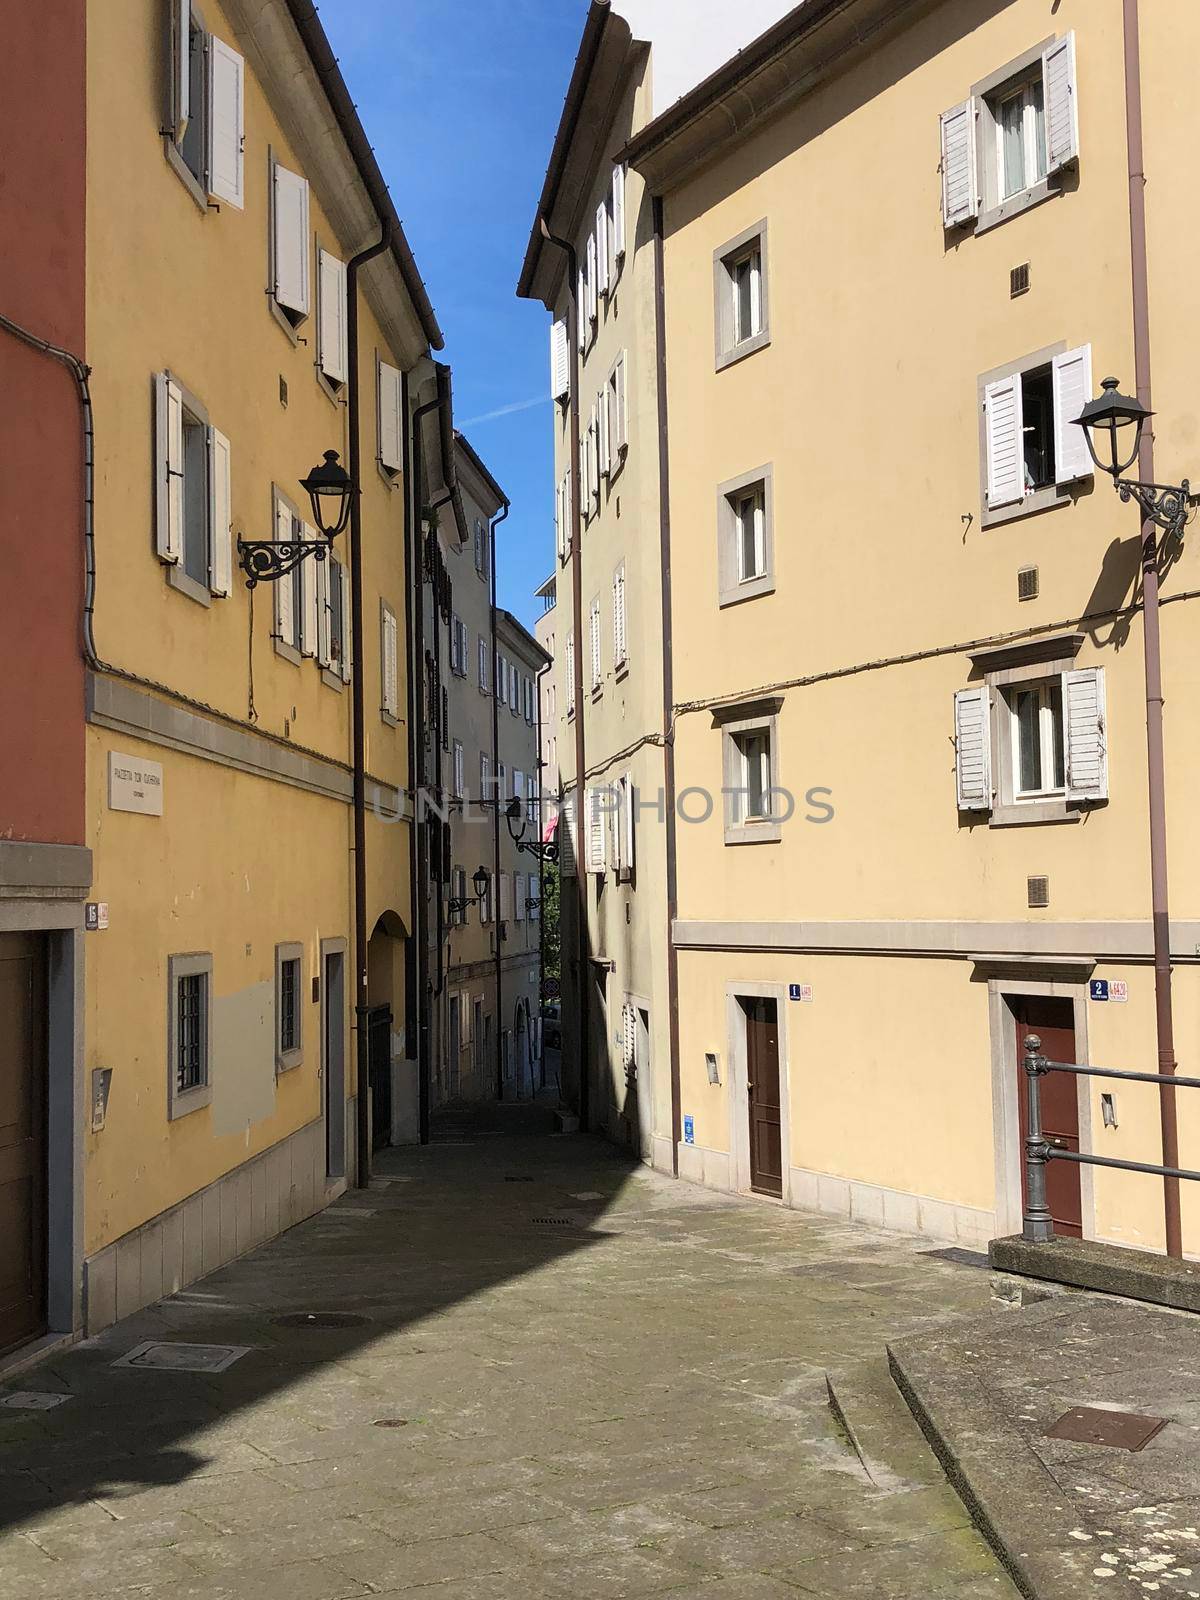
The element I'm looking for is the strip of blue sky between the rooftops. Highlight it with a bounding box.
[320,0,587,624]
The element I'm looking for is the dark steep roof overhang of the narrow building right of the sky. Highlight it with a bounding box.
[517,0,643,310]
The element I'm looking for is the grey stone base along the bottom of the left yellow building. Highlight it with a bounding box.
[83,1099,355,1334]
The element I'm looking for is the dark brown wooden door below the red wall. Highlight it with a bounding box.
[0,933,46,1350]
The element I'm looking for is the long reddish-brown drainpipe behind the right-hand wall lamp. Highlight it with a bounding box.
[1123,0,1182,1259]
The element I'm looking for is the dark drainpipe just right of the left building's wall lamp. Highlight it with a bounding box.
[346,218,392,1189]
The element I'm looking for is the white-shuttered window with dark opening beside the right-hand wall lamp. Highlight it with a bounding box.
[979,344,1093,526]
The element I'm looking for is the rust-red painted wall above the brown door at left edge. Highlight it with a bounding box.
[0,0,86,843]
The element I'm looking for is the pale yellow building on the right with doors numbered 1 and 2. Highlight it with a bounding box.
[531,0,1200,1254]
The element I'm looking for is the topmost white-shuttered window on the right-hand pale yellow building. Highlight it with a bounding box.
[941,34,1078,232]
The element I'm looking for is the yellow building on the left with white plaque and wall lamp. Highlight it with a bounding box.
[80,0,448,1331]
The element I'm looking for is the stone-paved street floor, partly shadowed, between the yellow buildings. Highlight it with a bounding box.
[0,1118,1014,1600]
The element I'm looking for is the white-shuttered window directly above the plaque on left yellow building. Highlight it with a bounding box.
[154,373,234,605]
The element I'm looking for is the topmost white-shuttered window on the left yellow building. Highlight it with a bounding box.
[163,0,245,211]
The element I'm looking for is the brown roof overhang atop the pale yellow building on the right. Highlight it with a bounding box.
[621,0,944,194]
